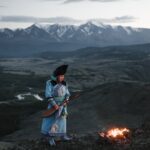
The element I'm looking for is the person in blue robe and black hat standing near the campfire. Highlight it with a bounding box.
[41,65,71,145]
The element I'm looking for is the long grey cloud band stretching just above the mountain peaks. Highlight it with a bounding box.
[0,15,138,24]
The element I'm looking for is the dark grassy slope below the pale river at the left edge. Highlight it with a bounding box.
[0,100,46,137]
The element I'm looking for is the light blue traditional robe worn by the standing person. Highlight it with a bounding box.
[41,80,70,136]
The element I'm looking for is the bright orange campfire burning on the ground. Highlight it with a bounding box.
[98,128,130,144]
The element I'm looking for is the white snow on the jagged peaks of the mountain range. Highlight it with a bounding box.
[20,20,144,38]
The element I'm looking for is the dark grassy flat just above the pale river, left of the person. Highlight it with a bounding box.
[0,72,47,101]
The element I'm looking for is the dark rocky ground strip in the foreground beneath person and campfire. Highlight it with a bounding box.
[0,122,150,150]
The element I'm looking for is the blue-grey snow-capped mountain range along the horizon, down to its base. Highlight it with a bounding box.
[0,22,150,57]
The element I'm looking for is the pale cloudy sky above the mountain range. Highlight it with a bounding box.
[0,0,150,29]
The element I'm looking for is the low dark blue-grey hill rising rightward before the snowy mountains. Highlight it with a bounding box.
[39,43,150,61]
